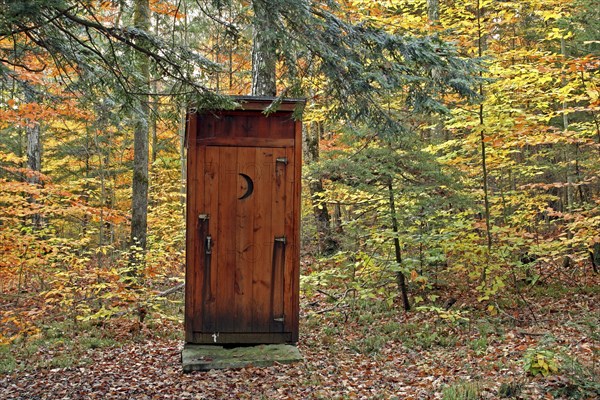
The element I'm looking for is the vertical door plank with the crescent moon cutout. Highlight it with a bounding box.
[234,148,257,332]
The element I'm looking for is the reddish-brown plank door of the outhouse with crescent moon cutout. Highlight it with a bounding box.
[194,146,294,343]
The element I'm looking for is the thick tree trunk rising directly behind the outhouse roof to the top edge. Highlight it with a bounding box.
[252,0,277,96]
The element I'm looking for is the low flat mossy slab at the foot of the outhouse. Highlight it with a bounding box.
[181,343,302,372]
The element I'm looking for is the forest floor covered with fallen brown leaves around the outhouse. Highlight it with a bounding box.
[0,266,600,399]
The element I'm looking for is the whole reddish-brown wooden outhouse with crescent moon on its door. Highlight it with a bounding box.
[185,97,303,344]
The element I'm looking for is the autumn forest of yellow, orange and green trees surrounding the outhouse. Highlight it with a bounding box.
[0,0,600,360]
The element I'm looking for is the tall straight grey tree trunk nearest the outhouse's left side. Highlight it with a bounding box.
[130,0,150,266]
